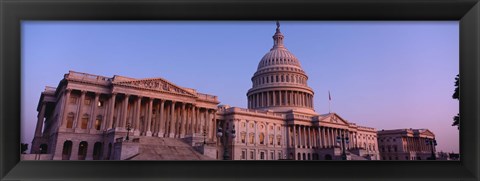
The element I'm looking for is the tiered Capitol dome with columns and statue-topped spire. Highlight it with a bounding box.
[247,23,314,111]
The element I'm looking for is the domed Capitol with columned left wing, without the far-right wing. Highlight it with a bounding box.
[31,23,380,160]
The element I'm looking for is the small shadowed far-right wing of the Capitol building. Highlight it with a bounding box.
[378,128,436,160]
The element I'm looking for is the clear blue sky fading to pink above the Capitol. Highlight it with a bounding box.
[21,21,459,152]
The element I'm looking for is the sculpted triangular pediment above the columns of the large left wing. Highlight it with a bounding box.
[113,78,196,97]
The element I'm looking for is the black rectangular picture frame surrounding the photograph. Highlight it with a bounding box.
[0,0,480,180]
